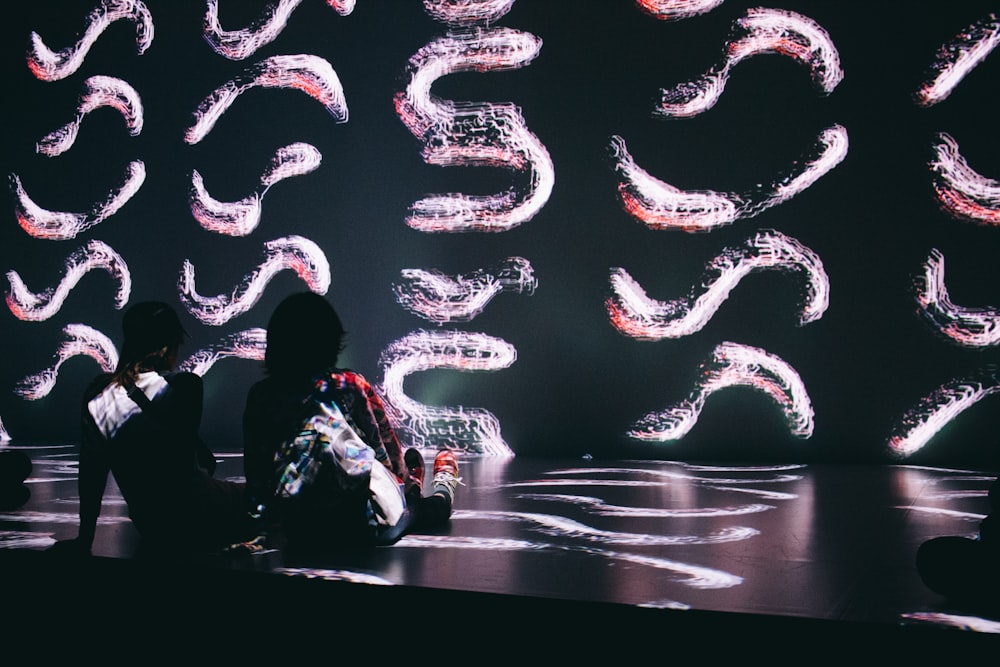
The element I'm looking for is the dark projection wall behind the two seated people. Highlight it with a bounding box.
[0,0,1000,465]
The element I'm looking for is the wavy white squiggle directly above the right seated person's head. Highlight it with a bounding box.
[177,236,330,326]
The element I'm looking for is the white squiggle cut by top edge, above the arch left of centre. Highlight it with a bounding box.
[203,0,355,60]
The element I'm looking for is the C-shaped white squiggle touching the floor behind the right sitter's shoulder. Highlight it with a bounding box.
[379,331,517,456]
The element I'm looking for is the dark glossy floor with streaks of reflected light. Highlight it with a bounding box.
[0,446,1000,649]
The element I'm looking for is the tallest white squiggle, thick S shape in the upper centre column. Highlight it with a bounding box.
[395,28,555,232]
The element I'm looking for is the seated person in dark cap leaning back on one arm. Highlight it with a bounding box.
[53,301,255,553]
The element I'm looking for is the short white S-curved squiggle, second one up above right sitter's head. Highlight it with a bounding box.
[188,143,323,236]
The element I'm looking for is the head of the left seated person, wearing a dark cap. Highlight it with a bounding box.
[114,301,188,384]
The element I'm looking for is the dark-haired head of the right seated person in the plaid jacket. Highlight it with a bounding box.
[264,292,347,378]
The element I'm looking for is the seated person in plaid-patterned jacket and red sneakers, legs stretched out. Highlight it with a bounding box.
[243,292,460,544]
